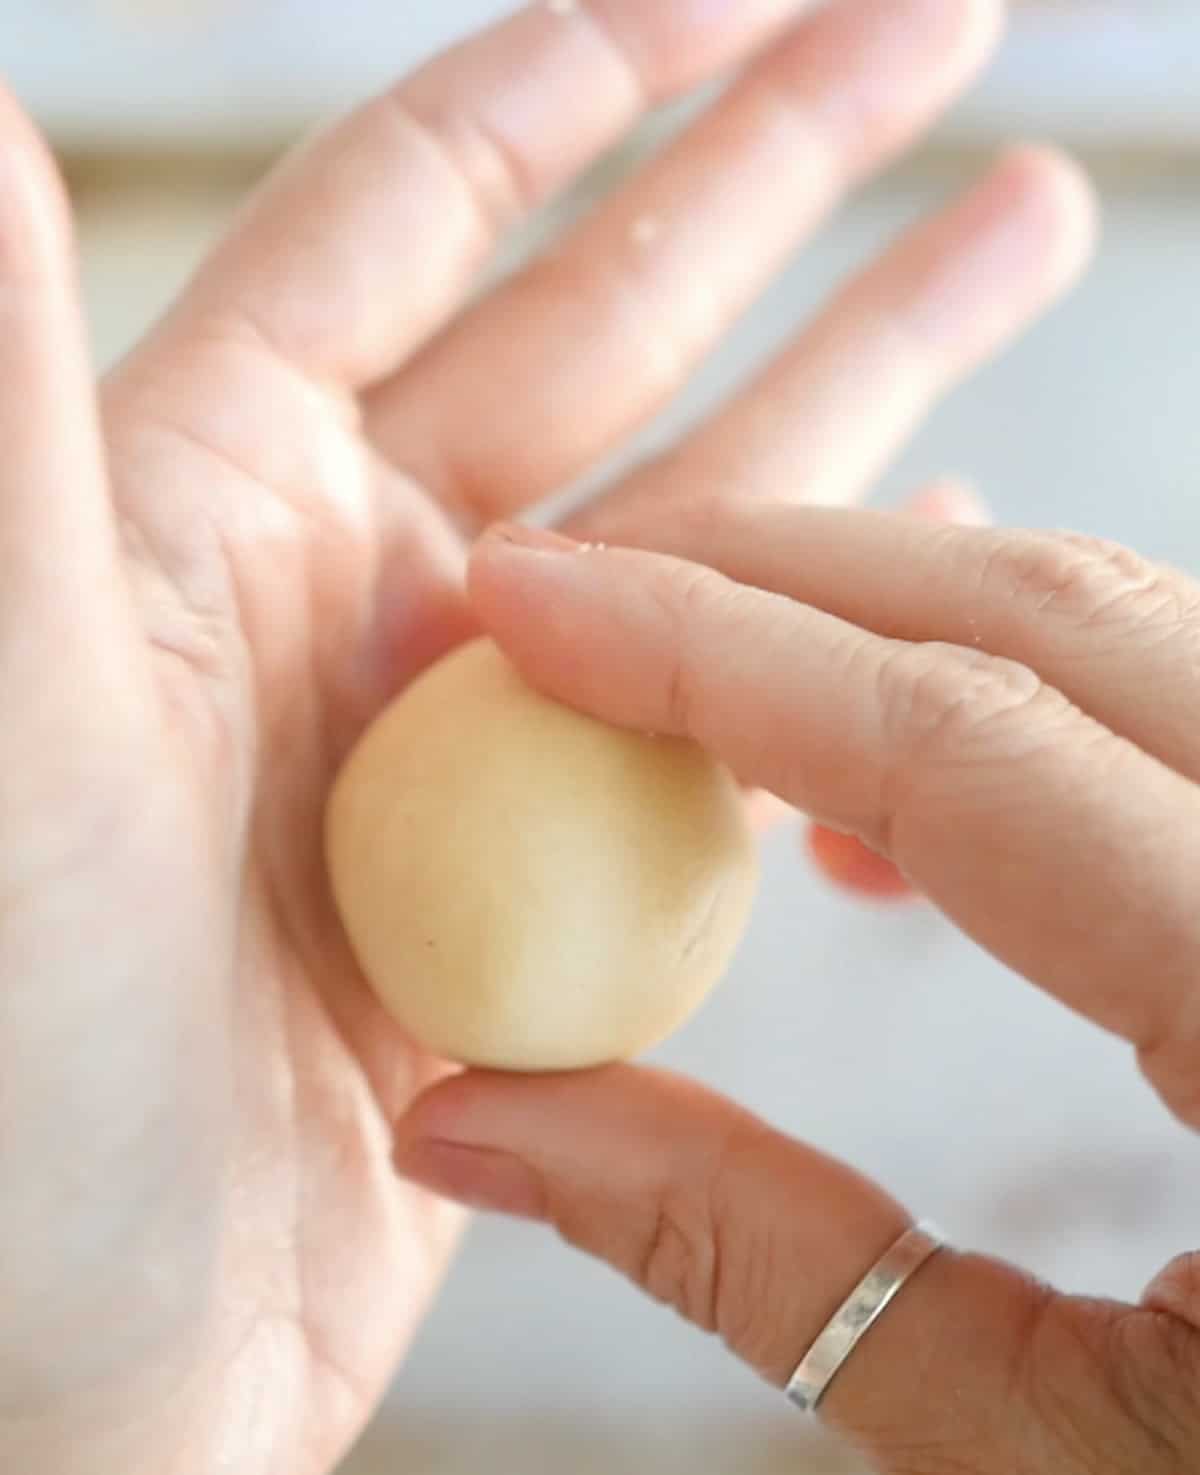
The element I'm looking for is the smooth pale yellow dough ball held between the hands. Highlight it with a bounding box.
[326,640,758,1071]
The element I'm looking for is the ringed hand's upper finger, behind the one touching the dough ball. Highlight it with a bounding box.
[598,504,1200,779]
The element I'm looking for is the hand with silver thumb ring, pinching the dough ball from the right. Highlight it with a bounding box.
[401,500,1200,1475]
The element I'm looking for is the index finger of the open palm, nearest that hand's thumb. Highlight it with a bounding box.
[171,0,799,388]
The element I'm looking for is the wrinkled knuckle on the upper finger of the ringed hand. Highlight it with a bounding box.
[982,532,1200,643]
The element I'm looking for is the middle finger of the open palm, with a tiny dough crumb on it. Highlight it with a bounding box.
[371,0,1000,519]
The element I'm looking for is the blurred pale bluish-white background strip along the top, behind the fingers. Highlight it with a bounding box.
[0,0,1200,152]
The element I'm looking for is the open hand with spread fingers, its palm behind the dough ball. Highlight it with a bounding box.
[0,0,1086,1475]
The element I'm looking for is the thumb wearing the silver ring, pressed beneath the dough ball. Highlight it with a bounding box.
[397,1066,1200,1475]
